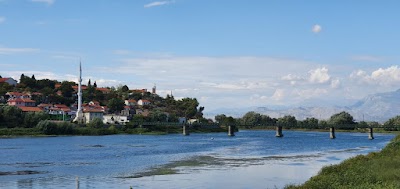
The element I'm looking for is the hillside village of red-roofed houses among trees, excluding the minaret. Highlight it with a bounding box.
[0,74,206,124]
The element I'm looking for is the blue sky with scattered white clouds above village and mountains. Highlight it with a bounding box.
[0,0,400,113]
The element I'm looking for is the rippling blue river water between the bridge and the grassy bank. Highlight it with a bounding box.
[0,131,394,189]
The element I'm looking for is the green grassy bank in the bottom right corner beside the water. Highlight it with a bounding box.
[286,135,400,189]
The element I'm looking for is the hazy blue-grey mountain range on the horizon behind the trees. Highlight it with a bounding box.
[208,89,400,123]
